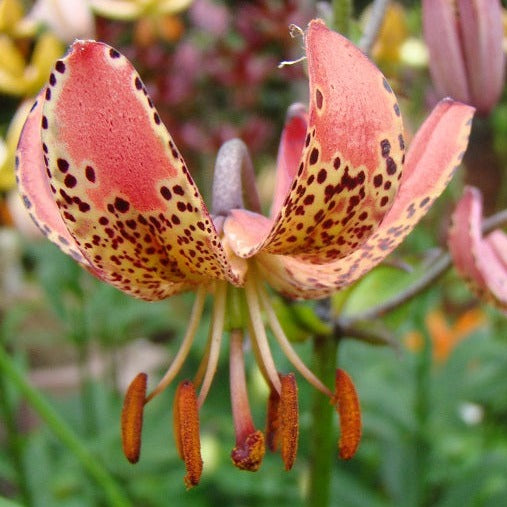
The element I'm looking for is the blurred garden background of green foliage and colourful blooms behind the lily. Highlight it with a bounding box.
[0,0,507,507]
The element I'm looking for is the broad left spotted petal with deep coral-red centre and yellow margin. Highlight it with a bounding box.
[41,41,236,300]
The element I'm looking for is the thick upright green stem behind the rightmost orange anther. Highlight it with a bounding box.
[307,336,339,507]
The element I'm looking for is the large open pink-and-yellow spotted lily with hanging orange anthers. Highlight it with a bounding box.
[17,20,473,487]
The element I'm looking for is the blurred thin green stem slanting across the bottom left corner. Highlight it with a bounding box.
[0,346,132,507]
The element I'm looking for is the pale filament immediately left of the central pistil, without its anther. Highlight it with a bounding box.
[198,282,227,408]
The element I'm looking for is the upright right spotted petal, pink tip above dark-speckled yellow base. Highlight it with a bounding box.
[226,20,404,263]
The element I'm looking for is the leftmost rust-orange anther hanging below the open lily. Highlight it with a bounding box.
[121,373,148,463]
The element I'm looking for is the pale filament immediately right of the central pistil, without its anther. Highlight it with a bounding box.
[245,278,282,393]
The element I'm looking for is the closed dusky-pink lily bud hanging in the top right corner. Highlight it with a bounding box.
[422,0,505,114]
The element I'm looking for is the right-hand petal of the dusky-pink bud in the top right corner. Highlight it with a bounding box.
[458,0,505,113]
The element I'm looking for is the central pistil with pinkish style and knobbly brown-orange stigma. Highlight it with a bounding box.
[229,329,265,472]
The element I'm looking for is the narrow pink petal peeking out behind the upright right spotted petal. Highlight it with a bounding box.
[271,104,308,219]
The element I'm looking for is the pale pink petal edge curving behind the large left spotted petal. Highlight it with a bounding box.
[16,95,90,268]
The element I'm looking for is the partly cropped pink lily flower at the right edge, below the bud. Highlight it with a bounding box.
[448,187,507,312]
